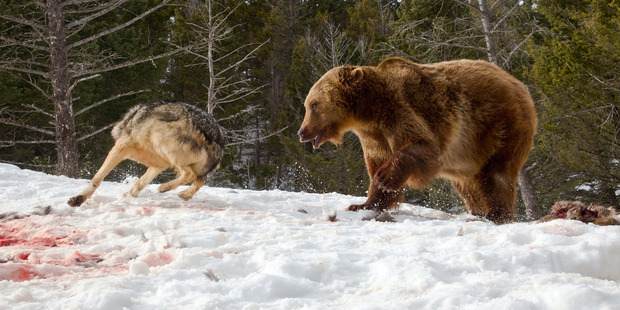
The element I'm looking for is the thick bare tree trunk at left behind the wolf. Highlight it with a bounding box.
[47,0,79,178]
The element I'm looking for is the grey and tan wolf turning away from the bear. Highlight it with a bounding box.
[67,102,225,207]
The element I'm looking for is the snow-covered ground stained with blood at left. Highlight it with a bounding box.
[0,164,620,310]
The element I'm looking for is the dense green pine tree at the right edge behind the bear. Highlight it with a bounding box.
[529,0,620,205]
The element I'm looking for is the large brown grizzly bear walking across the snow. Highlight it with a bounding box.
[298,58,537,224]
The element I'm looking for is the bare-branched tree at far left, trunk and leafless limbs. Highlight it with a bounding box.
[0,0,176,177]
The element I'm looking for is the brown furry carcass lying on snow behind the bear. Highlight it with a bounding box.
[538,201,620,226]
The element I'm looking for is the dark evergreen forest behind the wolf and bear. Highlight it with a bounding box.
[0,0,620,219]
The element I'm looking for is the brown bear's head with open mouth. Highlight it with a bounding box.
[297,66,364,149]
